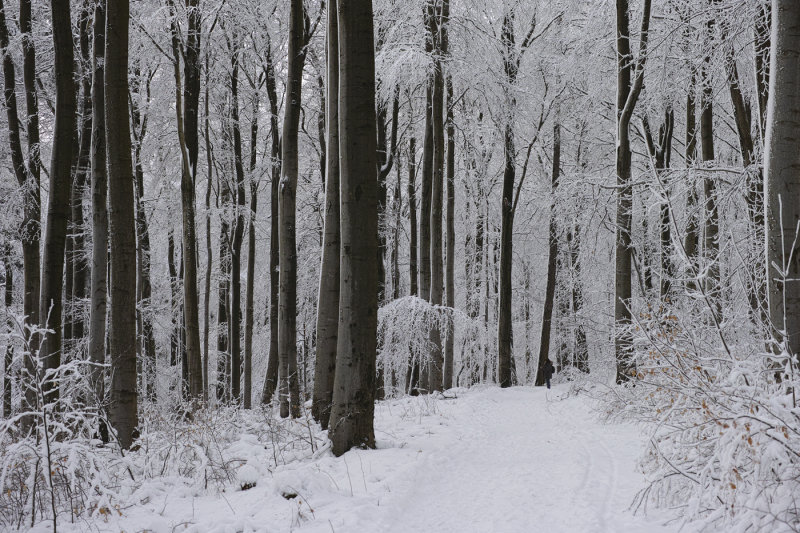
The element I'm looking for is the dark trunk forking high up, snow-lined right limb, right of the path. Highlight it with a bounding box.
[614,0,651,383]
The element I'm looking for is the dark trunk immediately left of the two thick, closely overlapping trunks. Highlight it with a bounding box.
[278,0,306,418]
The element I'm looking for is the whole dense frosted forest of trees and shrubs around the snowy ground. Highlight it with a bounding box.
[0,0,800,528]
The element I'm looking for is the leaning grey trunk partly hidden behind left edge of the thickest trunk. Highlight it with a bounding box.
[311,0,340,429]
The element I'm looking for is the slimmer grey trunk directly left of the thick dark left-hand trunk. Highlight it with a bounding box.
[89,0,108,414]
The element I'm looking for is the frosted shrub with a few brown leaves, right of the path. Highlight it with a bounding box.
[614,304,800,531]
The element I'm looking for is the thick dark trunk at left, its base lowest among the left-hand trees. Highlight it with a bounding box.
[104,0,139,449]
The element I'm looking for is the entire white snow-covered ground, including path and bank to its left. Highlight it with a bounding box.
[35,386,687,533]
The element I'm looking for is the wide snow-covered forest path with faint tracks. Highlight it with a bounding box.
[368,387,670,533]
